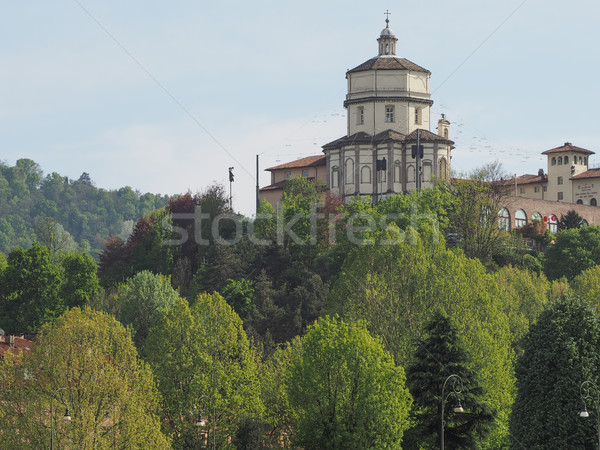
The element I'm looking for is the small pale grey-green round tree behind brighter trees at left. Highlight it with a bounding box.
[117,270,179,348]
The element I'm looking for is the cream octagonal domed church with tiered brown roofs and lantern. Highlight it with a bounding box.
[323,19,454,203]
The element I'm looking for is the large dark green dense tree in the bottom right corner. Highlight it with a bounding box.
[510,297,600,450]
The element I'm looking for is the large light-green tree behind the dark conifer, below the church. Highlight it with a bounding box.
[326,226,514,446]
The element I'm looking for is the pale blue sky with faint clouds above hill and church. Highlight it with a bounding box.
[0,0,600,216]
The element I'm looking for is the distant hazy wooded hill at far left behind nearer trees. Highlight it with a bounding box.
[0,158,168,255]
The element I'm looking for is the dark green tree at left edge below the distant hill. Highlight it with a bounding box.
[0,243,65,333]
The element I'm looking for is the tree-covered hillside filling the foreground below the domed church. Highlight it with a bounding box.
[0,171,600,449]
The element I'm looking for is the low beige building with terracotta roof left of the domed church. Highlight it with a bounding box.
[259,155,327,208]
